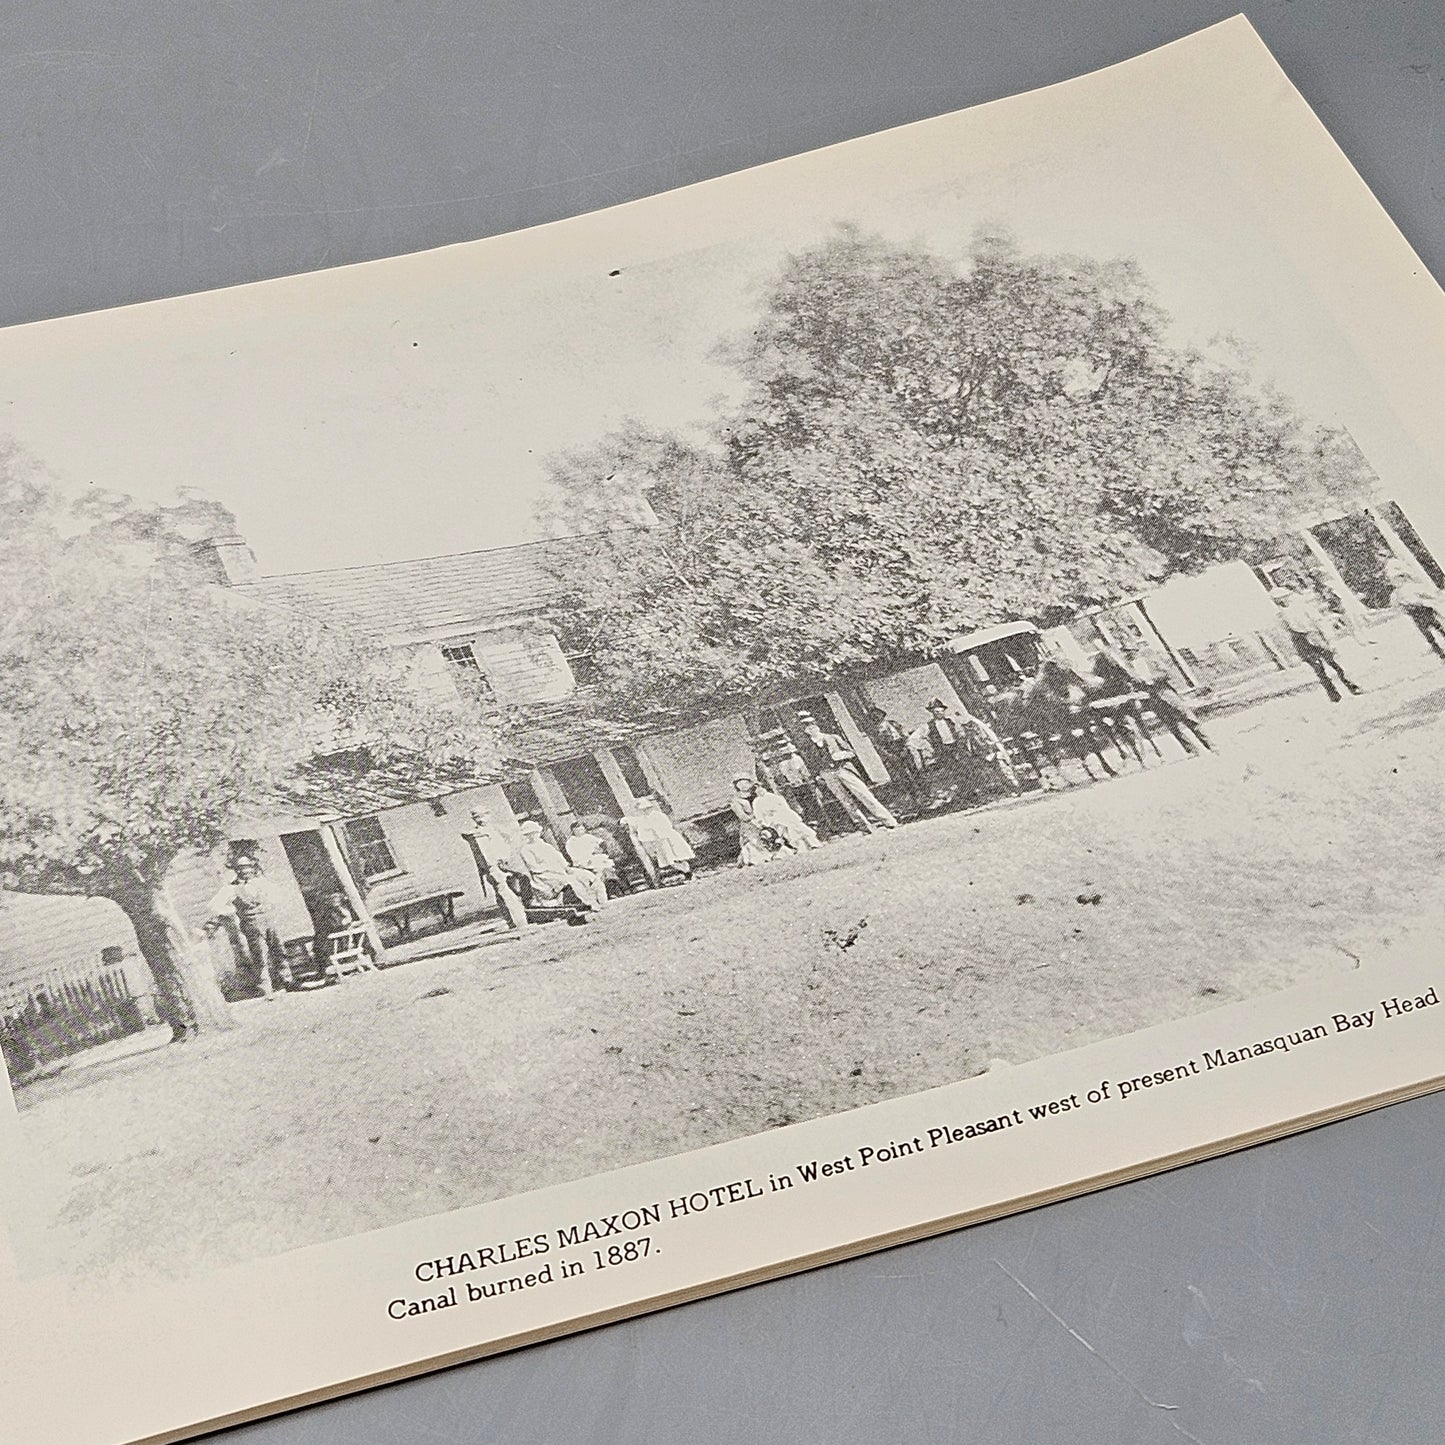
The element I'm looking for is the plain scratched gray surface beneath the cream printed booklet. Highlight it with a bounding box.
[0,0,1445,1445]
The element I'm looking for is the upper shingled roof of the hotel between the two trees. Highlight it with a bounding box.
[236,542,575,637]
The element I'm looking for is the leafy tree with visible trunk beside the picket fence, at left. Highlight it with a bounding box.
[0,449,493,1029]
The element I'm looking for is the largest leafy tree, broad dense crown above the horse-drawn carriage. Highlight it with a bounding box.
[545,227,1371,715]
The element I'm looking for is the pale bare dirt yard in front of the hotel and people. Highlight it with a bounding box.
[19,644,1445,1273]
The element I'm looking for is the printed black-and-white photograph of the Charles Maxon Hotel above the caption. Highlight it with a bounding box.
[0,16,1445,1323]
